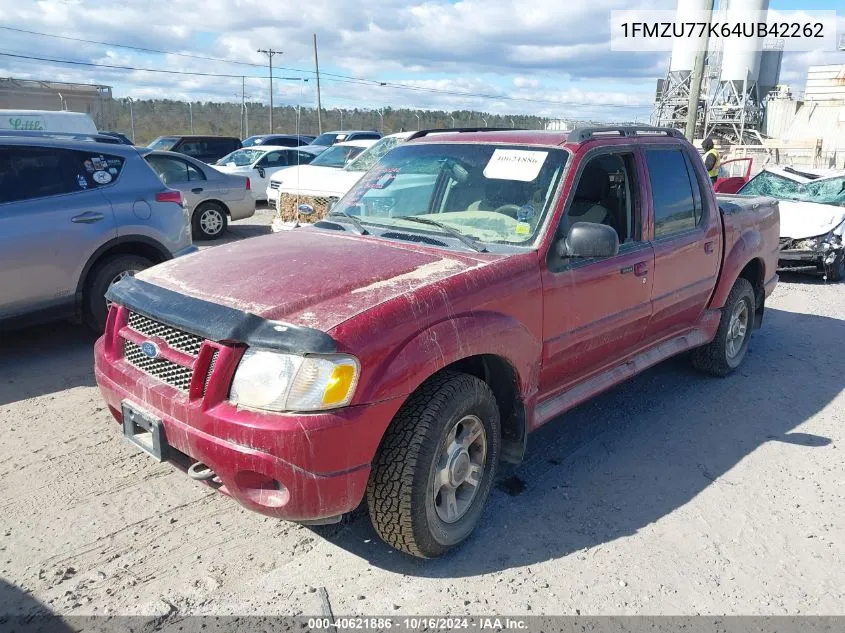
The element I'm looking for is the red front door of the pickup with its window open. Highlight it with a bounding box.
[540,148,654,400]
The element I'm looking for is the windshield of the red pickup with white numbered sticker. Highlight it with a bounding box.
[330,143,568,245]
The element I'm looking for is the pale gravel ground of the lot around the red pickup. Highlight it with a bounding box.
[0,211,845,621]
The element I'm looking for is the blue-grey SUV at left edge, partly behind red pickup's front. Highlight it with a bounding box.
[0,132,196,332]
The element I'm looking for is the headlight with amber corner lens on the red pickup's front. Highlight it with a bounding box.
[229,349,361,411]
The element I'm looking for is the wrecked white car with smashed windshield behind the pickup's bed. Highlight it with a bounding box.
[738,167,845,281]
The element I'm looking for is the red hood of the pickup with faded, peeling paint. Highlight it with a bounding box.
[137,228,484,331]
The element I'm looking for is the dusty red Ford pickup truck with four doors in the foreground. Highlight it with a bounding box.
[95,128,779,557]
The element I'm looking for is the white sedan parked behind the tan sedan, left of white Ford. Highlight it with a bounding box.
[213,145,322,200]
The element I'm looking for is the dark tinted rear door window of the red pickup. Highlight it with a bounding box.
[645,149,701,239]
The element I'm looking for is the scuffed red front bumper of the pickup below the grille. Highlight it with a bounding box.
[94,334,401,522]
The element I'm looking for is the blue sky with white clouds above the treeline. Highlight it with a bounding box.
[0,0,845,121]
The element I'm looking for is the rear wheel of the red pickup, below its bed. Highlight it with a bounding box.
[692,278,755,376]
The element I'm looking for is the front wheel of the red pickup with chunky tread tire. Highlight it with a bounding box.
[367,371,501,558]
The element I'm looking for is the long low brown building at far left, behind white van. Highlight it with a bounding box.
[0,77,113,129]
